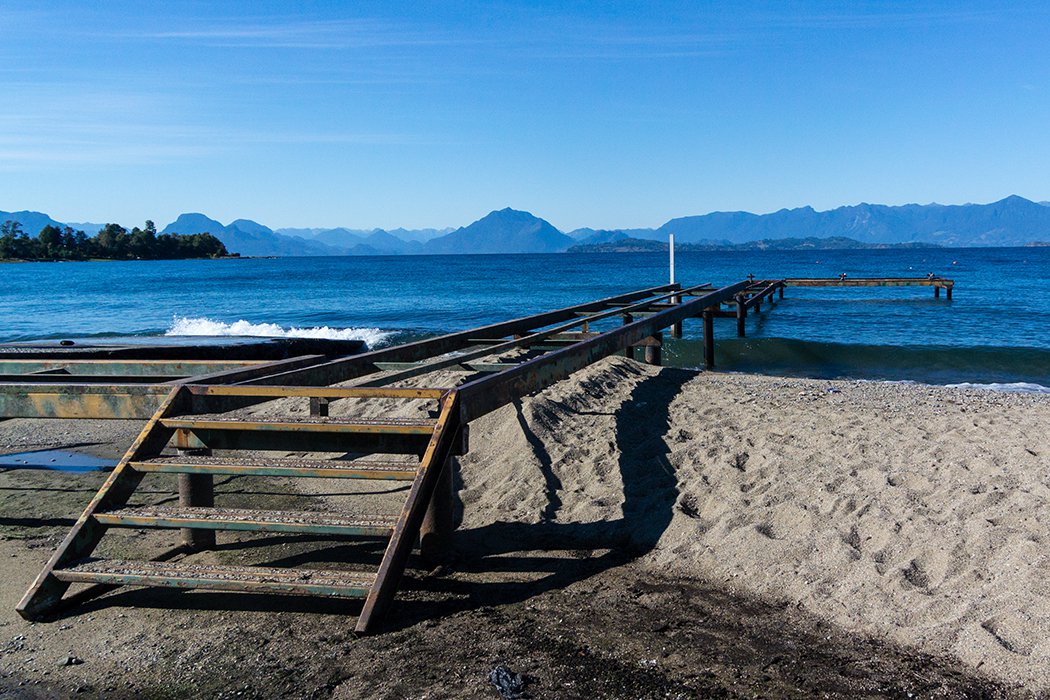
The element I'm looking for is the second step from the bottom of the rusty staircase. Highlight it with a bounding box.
[95,506,397,537]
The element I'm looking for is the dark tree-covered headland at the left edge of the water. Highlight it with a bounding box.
[0,220,236,260]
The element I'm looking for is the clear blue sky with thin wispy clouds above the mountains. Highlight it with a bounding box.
[0,0,1050,230]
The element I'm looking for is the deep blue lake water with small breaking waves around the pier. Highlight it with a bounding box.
[0,248,1050,385]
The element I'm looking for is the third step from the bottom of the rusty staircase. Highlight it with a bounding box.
[131,457,419,481]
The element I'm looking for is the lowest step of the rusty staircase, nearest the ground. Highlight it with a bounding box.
[51,559,376,598]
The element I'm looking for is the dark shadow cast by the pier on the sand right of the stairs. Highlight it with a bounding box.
[389,368,696,627]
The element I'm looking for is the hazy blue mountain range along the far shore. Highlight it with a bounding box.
[6,195,1050,256]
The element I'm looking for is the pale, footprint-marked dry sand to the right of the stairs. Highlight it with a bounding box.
[453,359,1050,690]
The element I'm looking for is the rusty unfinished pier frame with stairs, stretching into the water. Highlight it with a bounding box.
[0,278,951,633]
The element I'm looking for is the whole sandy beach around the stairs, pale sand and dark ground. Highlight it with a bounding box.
[0,358,1050,698]
